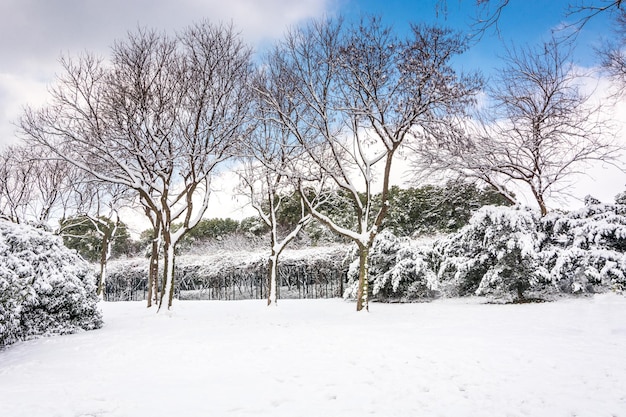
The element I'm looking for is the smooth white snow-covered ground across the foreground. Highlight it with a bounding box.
[0,294,626,417]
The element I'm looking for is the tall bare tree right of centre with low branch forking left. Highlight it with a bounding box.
[264,18,480,310]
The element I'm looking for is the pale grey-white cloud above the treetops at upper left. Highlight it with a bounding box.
[0,0,335,149]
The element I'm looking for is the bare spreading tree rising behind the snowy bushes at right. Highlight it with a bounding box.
[418,40,621,215]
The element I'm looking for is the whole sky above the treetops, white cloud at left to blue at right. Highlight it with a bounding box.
[0,0,626,214]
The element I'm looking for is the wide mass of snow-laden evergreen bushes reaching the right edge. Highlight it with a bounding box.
[432,199,626,299]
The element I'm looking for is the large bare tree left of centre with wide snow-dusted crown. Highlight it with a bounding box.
[21,22,250,307]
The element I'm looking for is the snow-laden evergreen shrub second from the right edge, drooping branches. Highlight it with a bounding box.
[433,206,547,300]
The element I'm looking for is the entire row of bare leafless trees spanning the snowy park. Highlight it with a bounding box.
[0,4,619,310]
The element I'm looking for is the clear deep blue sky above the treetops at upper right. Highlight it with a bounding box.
[340,0,614,73]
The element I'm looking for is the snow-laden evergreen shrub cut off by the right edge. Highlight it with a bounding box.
[541,198,626,293]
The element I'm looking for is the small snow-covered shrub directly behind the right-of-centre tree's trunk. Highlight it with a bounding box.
[344,230,437,301]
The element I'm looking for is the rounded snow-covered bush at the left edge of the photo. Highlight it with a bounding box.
[0,221,102,346]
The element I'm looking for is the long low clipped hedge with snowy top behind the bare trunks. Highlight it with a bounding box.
[105,245,347,301]
